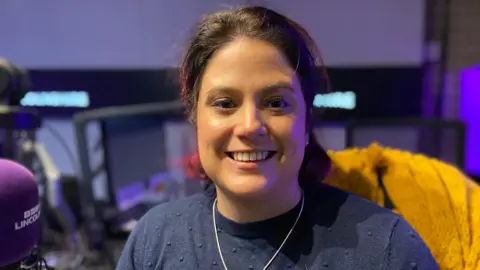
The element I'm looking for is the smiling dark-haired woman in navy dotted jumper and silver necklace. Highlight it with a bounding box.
[117,4,438,270]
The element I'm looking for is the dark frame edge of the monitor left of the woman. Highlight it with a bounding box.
[73,101,185,250]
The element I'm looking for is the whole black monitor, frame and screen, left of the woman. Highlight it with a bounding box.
[74,102,202,249]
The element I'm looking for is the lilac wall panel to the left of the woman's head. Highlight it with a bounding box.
[0,0,244,68]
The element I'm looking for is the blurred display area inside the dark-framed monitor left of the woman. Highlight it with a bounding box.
[103,115,201,211]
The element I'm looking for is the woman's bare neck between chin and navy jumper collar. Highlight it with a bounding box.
[217,184,302,223]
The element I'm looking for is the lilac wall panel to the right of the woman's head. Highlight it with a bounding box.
[269,0,425,66]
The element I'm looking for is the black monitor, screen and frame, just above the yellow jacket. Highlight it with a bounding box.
[346,119,465,169]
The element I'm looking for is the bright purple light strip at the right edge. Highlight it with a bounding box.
[460,65,480,175]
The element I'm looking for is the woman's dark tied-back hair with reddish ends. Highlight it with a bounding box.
[180,6,330,184]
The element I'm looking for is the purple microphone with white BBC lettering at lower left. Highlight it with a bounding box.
[0,159,40,267]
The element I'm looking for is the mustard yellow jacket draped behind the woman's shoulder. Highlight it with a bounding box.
[325,144,480,270]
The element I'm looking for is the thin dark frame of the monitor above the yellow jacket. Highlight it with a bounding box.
[345,118,466,170]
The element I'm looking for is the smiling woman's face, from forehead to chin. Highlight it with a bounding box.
[196,38,306,197]
